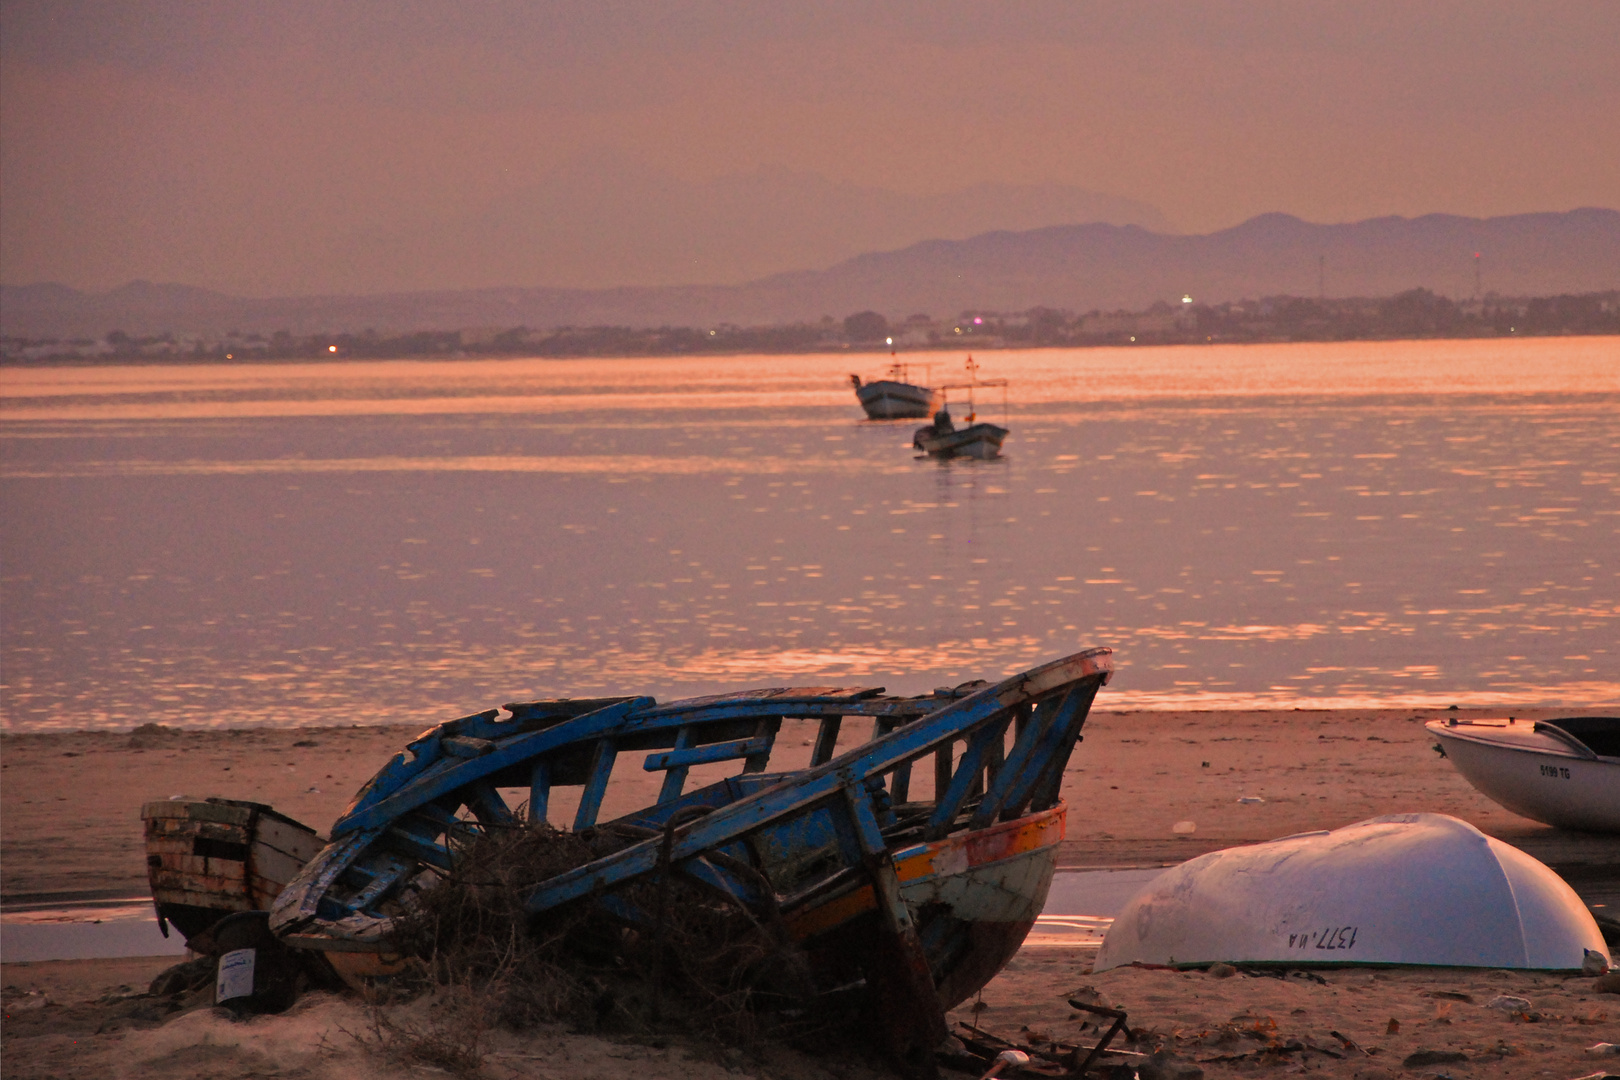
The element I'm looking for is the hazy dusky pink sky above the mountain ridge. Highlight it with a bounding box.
[0,0,1620,296]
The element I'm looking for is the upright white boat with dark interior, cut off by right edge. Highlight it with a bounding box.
[1426,716,1620,832]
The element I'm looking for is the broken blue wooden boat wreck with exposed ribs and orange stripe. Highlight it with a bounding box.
[271,649,1113,1061]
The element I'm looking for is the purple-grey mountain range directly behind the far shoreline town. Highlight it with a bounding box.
[0,209,1620,337]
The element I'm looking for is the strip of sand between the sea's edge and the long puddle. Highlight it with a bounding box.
[0,709,1620,904]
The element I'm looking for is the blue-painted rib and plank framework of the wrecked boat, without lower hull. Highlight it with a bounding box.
[271,649,1111,1003]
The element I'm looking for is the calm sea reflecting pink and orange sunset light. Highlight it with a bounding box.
[0,338,1620,730]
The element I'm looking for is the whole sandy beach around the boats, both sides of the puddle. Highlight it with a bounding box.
[0,709,1620,1080]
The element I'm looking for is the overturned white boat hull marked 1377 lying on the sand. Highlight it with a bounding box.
[1097,814,1607,972]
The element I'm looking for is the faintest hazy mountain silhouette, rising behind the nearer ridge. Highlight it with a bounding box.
[330,154,1170,288]
